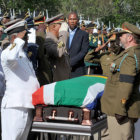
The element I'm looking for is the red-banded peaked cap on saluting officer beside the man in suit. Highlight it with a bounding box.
[45,14,64,24]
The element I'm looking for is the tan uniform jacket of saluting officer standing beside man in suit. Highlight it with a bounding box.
[44,32,70,81]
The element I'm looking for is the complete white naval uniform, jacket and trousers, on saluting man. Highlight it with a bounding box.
[1,38,39,140]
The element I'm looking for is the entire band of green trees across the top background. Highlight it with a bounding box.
[0,0,140,26]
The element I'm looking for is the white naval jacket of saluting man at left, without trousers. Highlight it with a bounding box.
[1,38,39,108]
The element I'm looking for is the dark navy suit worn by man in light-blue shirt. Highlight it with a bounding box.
[67,28,89,78]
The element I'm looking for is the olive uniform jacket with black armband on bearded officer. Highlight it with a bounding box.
[101,46,140,118]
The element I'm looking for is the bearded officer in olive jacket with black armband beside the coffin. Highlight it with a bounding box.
[101,22,140,140]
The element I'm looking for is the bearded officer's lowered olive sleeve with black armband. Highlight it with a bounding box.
[117,55,136,116]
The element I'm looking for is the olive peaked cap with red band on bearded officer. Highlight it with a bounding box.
[118,22,140,36]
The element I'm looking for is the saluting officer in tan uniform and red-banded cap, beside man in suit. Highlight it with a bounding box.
[44,14,71,81]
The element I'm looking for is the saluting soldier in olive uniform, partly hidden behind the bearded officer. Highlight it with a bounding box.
[85,34,122,76]
